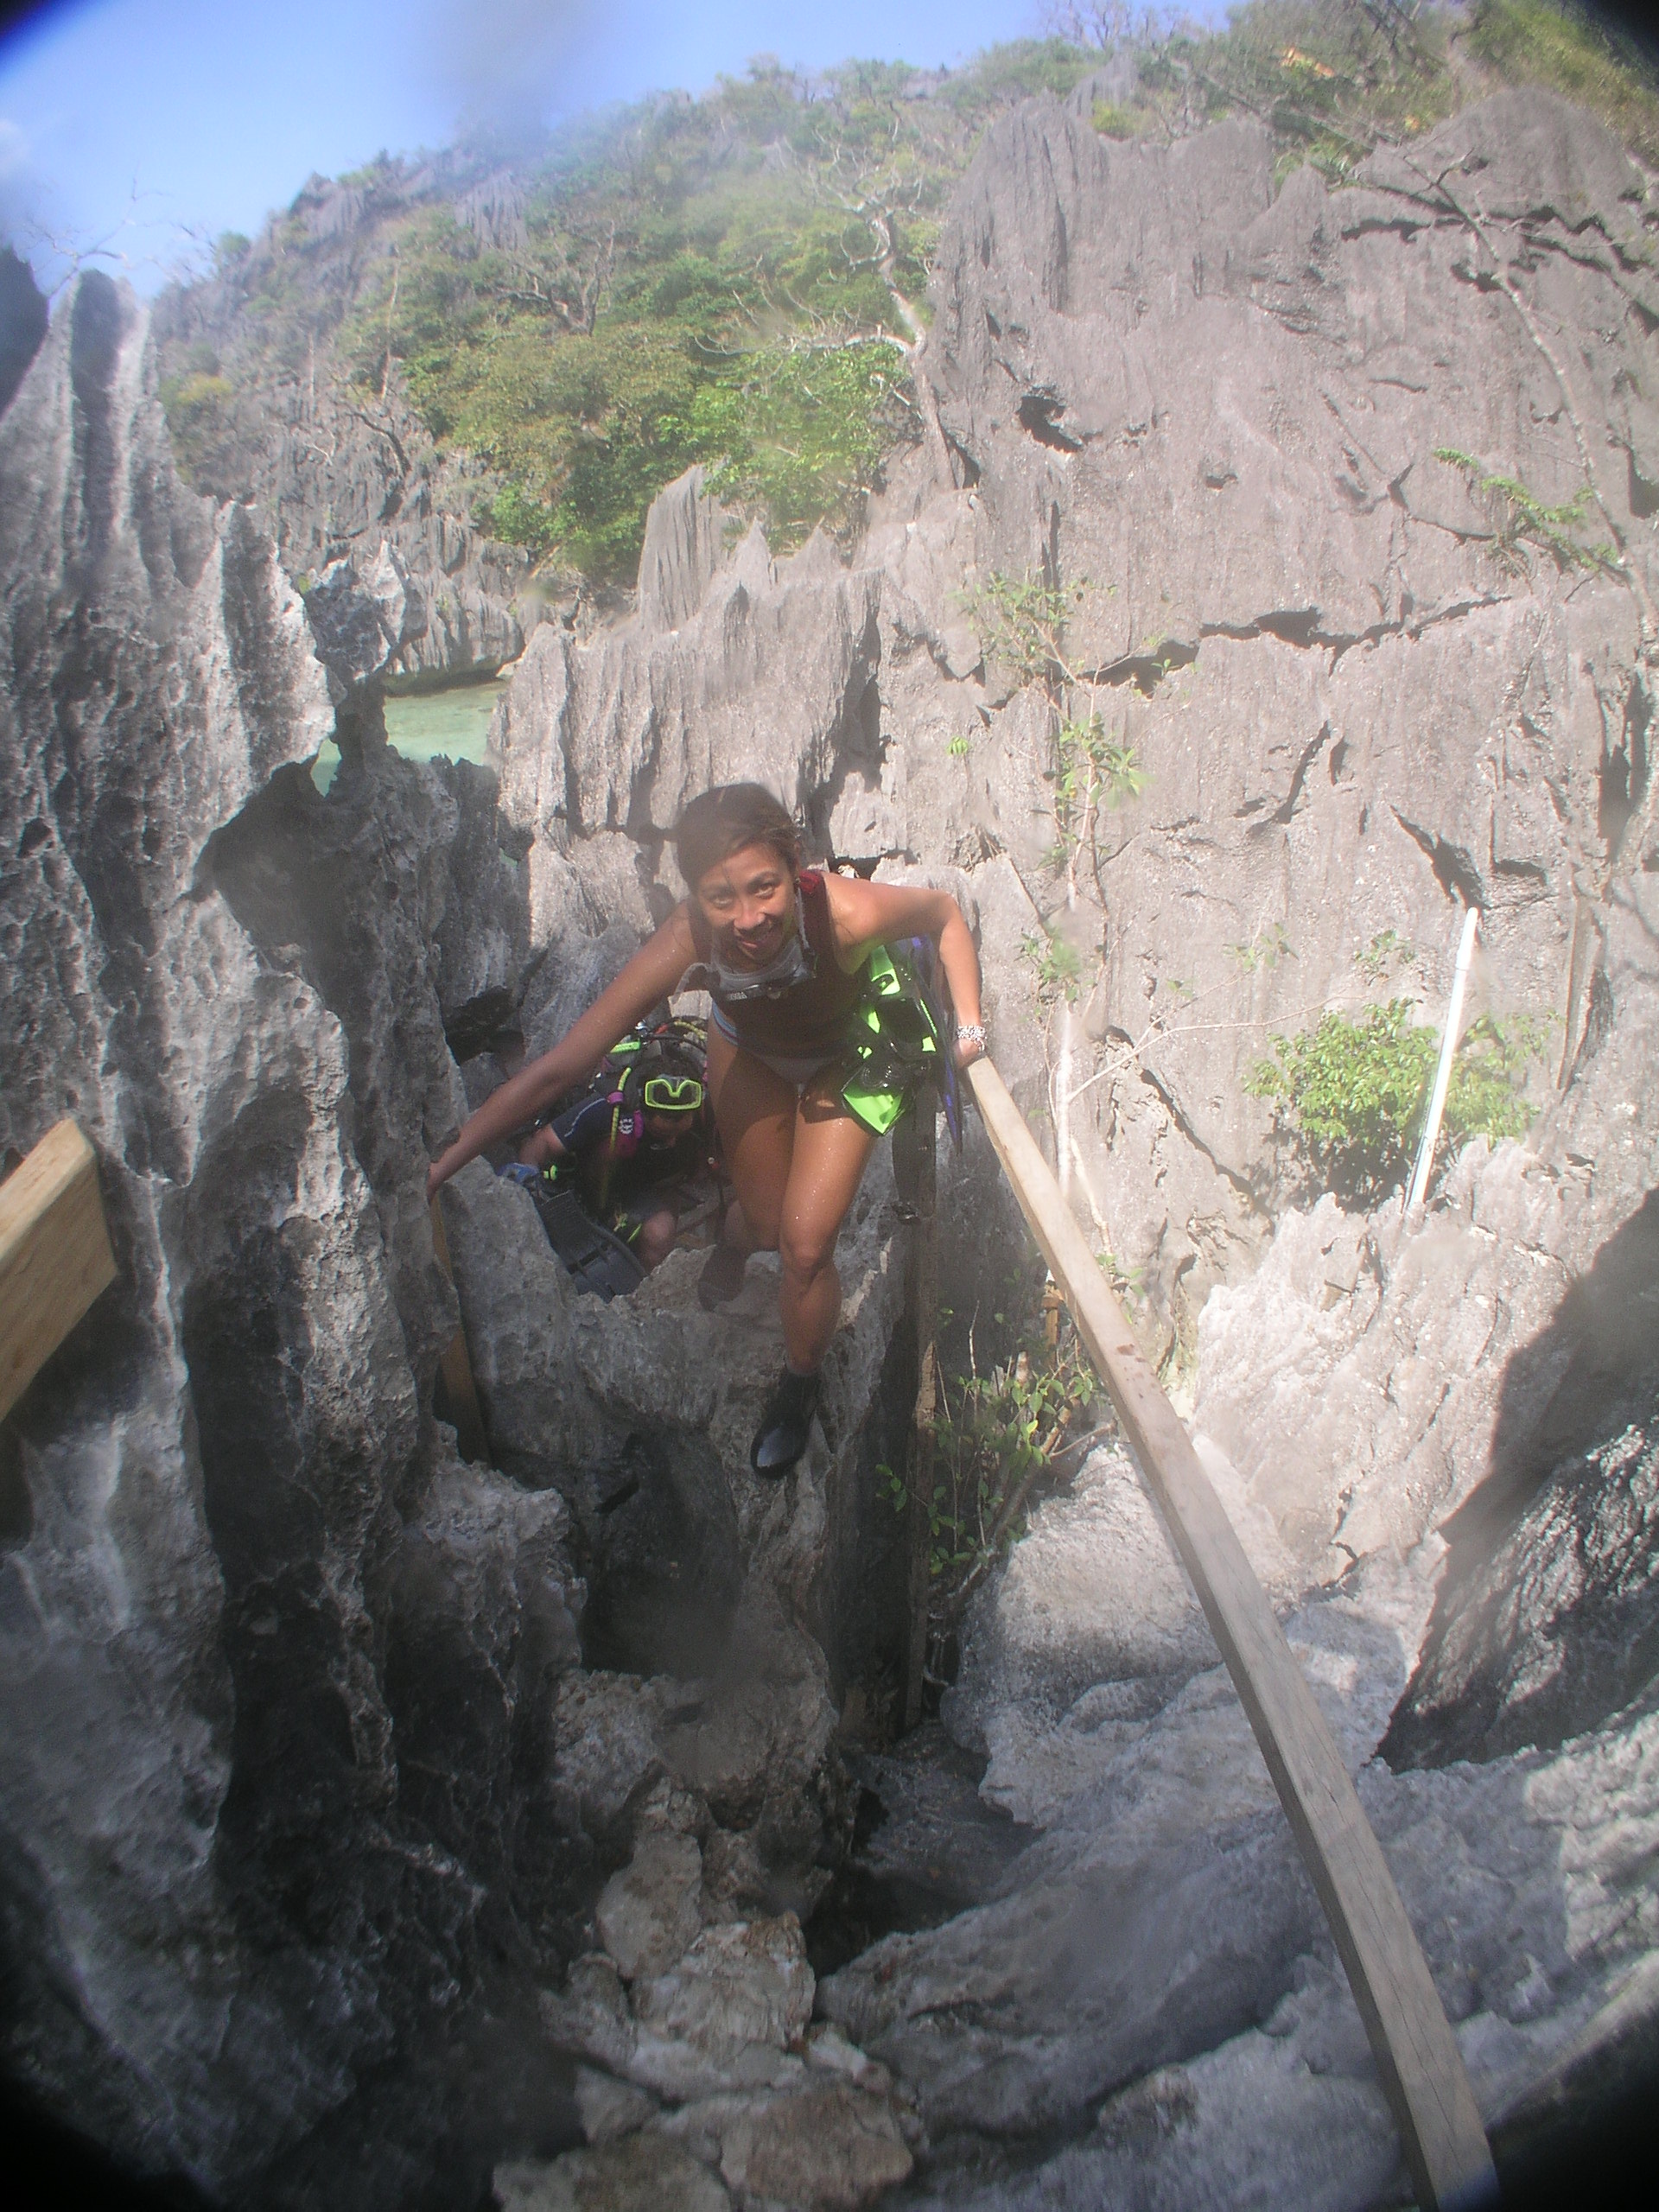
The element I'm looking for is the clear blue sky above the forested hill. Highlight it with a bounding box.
[0,0,1210,289]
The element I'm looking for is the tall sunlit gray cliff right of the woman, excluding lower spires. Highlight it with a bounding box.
[912,95,1659,1323]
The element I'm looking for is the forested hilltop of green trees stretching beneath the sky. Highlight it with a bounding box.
[163,0,1659,582]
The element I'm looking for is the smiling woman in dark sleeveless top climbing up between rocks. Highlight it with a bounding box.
[427,783,984,1476]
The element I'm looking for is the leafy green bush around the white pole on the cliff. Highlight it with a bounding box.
[1243,998,1551,1205]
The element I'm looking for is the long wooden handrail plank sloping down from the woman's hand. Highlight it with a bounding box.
[969,1059,1497,2212]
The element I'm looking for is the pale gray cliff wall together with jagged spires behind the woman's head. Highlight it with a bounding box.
[495,93,1659,1363]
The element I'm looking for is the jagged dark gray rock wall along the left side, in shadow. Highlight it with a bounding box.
[0,276,580,2203]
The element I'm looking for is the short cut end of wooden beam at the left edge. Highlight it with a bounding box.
[0,1122,115,1418]
